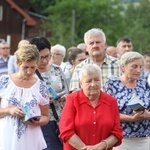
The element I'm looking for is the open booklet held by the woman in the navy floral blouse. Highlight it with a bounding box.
[127,95,146,111]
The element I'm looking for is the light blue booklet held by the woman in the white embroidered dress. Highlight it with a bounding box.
[22,106,41,121]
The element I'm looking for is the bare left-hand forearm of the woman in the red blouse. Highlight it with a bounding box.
[68,134,86,150]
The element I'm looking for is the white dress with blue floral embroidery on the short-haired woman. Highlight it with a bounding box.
[0,75,49,150]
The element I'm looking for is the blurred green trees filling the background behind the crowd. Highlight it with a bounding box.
[30,0,150,54]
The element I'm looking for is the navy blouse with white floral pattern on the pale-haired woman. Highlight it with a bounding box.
[105,77,150,138]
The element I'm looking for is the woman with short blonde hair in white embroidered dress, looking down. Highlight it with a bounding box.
[0,44,49,150]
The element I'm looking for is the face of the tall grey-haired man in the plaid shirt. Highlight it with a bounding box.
[87,35,107,57]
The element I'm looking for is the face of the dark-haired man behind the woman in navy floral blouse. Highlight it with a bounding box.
[117,41,133,57]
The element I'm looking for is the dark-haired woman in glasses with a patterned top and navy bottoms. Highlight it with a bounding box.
[30,37,67,150]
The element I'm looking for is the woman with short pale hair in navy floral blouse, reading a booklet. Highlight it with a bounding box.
[105,52,150,150]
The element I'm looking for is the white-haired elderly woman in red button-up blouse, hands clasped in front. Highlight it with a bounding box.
[59,64,123,150]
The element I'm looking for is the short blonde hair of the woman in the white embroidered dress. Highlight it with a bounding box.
[15,43,40,62]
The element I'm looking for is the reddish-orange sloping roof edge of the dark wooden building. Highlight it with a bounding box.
[6,0,36,26]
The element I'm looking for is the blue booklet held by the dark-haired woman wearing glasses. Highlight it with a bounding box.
[48,87,66,100]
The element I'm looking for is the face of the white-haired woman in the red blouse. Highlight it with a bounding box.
[80,73,101,98]
